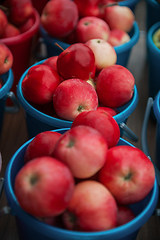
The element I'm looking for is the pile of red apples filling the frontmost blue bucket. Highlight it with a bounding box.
[14,125,155,232]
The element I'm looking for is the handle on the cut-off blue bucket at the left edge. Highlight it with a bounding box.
[5,92,20,113]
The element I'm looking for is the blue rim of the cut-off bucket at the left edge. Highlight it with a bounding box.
[0,68,14,99]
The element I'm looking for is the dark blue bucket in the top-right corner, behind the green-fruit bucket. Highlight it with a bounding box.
[146,0,160,31]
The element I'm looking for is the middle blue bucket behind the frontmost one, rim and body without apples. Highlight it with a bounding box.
[17,60,139,138]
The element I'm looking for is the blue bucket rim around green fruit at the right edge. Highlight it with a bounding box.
[147,21,160,57]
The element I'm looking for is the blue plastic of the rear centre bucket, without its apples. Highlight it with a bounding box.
[40,22,139,67]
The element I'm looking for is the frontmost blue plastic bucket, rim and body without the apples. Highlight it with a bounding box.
[4,131,159,240]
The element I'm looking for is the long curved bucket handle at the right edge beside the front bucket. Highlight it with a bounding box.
[141,97,160,186]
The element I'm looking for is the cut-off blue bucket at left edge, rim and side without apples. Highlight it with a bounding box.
[0,69,13,136]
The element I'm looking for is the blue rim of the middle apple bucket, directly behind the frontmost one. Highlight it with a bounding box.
[17,59,139,127]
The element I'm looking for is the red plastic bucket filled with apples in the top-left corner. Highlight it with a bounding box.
[0,0,40,106]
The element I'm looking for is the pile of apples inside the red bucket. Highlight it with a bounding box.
[0,0,34,39]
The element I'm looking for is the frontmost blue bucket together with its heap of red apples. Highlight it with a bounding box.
[0,125,158,240]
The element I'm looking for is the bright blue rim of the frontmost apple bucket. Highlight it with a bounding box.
[4,134,158,239]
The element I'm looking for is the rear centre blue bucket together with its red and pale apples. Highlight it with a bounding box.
[37,0,139,66]
